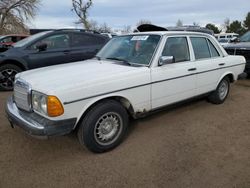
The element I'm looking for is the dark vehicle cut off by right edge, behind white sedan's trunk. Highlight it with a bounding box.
[224,31,250,76]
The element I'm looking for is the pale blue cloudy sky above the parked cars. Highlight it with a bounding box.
[28,0,250,29]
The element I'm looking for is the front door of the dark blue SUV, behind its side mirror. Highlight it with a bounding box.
[26,33,70,68]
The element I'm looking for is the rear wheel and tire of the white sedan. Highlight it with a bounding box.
[208,77,230,104]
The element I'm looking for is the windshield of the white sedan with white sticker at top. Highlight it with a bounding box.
[97,34,161,66]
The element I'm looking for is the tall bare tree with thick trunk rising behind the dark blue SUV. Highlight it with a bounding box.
[72,0,93,29]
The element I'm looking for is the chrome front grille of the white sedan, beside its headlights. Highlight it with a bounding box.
[14,79,31,111]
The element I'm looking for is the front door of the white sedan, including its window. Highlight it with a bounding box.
[151,36,196,109]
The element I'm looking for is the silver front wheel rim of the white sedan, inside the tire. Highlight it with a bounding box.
[94,112,123,145]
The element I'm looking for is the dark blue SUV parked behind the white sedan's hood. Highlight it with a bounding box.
[0,30,109,91]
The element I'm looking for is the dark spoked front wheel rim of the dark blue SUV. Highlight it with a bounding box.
[0,69,17,89]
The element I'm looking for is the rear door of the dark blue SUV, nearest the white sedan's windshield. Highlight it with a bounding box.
[70,32,106,61]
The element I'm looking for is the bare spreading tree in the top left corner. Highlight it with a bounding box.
[0,0,40,34]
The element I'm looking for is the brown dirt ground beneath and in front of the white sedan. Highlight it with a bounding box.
[0,80,250,188]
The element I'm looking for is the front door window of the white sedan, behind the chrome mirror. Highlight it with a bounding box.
[162,37,190,62]
